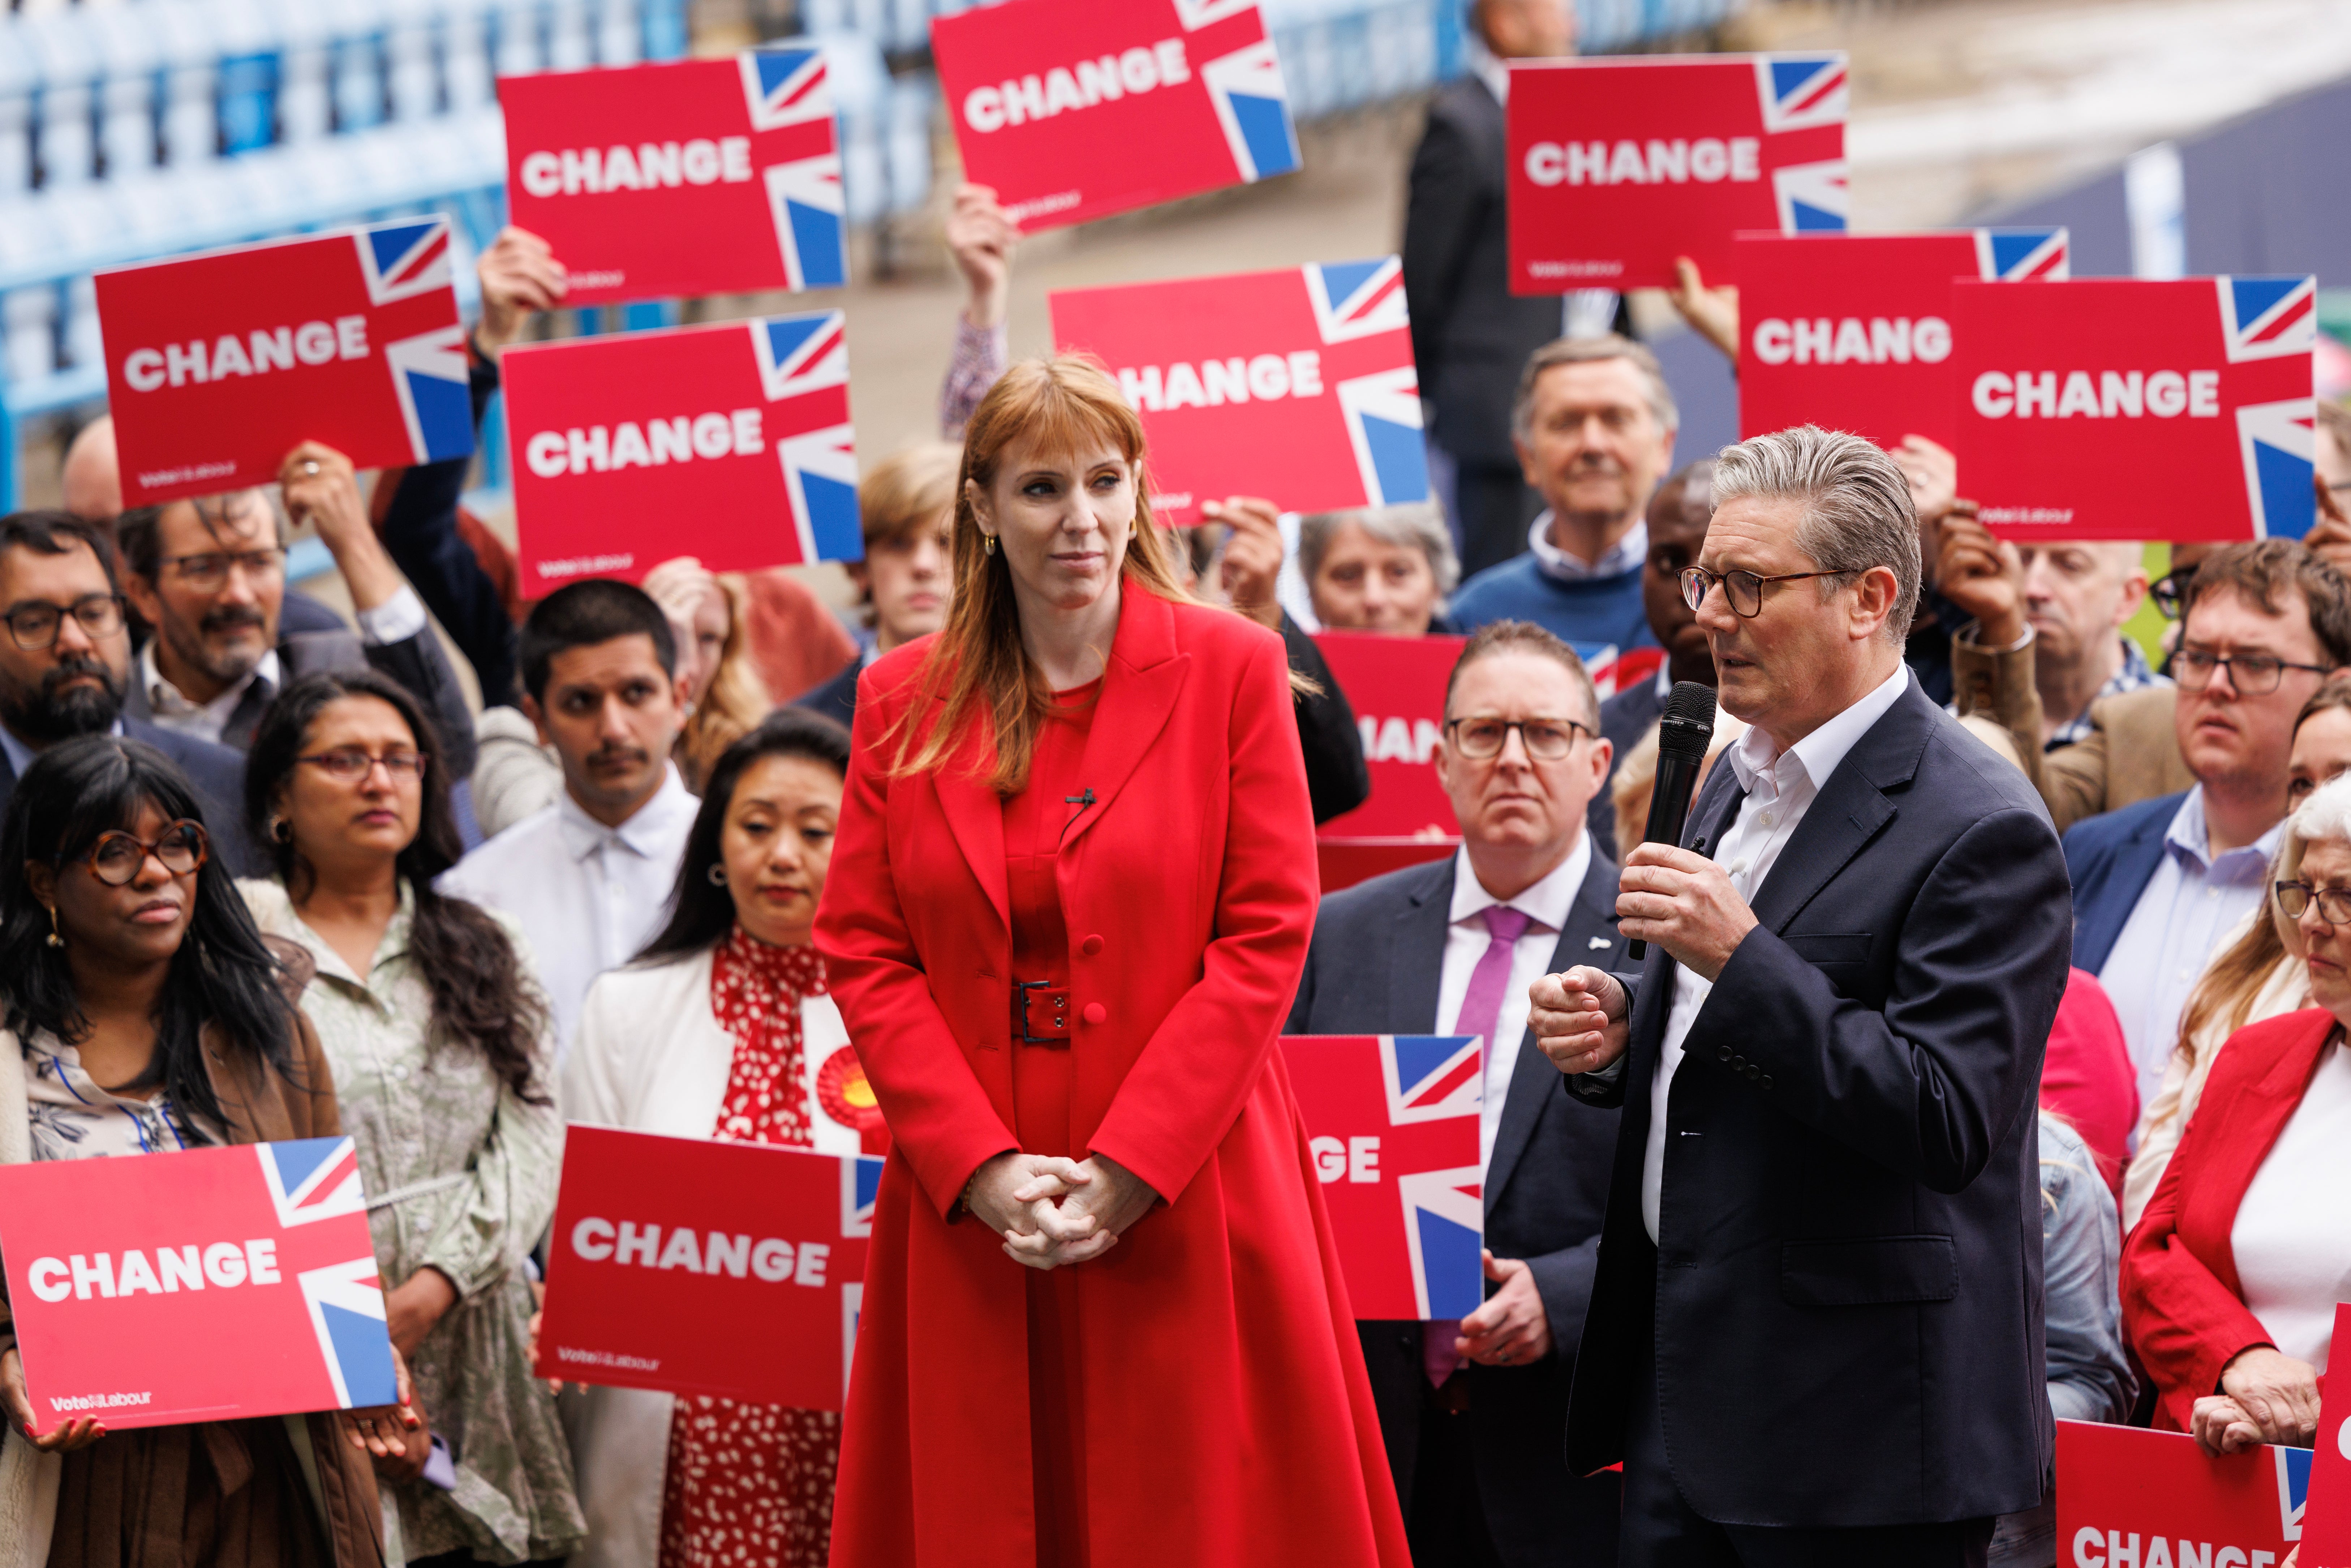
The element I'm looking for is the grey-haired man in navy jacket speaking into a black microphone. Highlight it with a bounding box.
[1533,428,2071,1568]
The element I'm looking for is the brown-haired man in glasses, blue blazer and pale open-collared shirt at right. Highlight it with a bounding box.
[2064,538,2351,1105]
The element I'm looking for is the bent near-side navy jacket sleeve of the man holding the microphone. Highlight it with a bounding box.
[1681,809,2073,1192]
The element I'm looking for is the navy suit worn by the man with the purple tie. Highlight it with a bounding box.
[1288,846,1620,1568]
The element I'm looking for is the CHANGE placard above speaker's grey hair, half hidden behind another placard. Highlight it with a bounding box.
[1730,228,2069,449]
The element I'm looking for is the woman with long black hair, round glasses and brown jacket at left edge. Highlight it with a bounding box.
[0,736,421,1568]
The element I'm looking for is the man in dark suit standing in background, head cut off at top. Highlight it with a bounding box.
[1404,0,1575,576]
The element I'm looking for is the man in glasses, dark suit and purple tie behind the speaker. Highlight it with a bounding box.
[1288,623,1617,1568]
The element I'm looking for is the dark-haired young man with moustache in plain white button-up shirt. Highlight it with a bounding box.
[437,578,698,1053]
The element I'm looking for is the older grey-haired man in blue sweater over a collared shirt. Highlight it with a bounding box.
[1453,336,1681,663]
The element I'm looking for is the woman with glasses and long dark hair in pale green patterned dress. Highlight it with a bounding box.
[237,670,585,1565]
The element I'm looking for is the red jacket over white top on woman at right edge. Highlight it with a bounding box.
[2123,1006,2334,1432]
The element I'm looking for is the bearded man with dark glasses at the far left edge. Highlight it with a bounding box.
[0,512,268,877]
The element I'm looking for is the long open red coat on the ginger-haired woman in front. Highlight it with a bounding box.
[816,583,1408,1568]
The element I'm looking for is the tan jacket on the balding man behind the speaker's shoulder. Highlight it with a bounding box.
[1951,628,2196,832]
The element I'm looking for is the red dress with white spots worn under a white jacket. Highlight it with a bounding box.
[661,926,842,1568]
